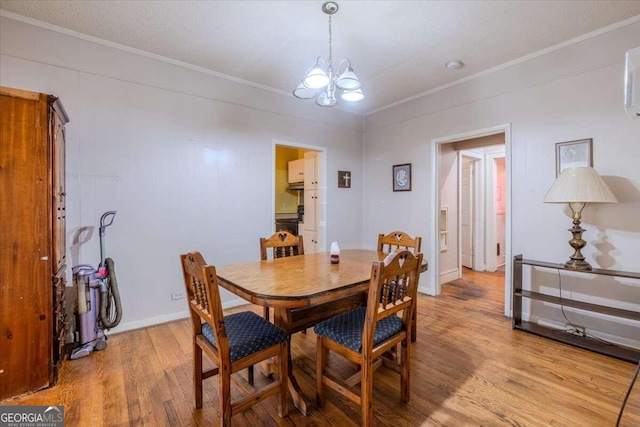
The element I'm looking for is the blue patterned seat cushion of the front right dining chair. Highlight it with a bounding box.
[313,307,402,353]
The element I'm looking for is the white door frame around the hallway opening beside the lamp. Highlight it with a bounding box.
[428,123,513,317]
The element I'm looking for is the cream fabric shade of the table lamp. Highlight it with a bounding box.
[544,166,618,203]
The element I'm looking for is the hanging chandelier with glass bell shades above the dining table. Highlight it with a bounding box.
[293,1,364,107]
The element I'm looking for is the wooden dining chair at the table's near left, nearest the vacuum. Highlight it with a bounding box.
[180,252,289,426]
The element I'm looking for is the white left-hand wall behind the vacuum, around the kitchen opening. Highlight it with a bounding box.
[0,17,362,330]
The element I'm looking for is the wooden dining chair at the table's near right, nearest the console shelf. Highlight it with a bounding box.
[314,250,422,427]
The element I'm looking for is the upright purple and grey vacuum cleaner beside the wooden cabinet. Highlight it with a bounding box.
[71,211,122,360]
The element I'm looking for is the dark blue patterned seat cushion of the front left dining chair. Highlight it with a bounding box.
[202,311,289,362]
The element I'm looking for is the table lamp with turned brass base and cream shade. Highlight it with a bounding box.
[544,166,618,270]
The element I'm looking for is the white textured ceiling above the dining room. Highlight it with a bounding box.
[0,0,640,114]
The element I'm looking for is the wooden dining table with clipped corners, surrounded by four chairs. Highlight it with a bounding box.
[216,249,427,415]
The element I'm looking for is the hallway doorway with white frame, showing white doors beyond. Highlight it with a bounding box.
[422,124,512,316]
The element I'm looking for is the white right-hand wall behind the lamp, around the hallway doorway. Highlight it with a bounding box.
[363,21,640,346]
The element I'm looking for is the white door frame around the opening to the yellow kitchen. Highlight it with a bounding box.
[271,138,327,252]
